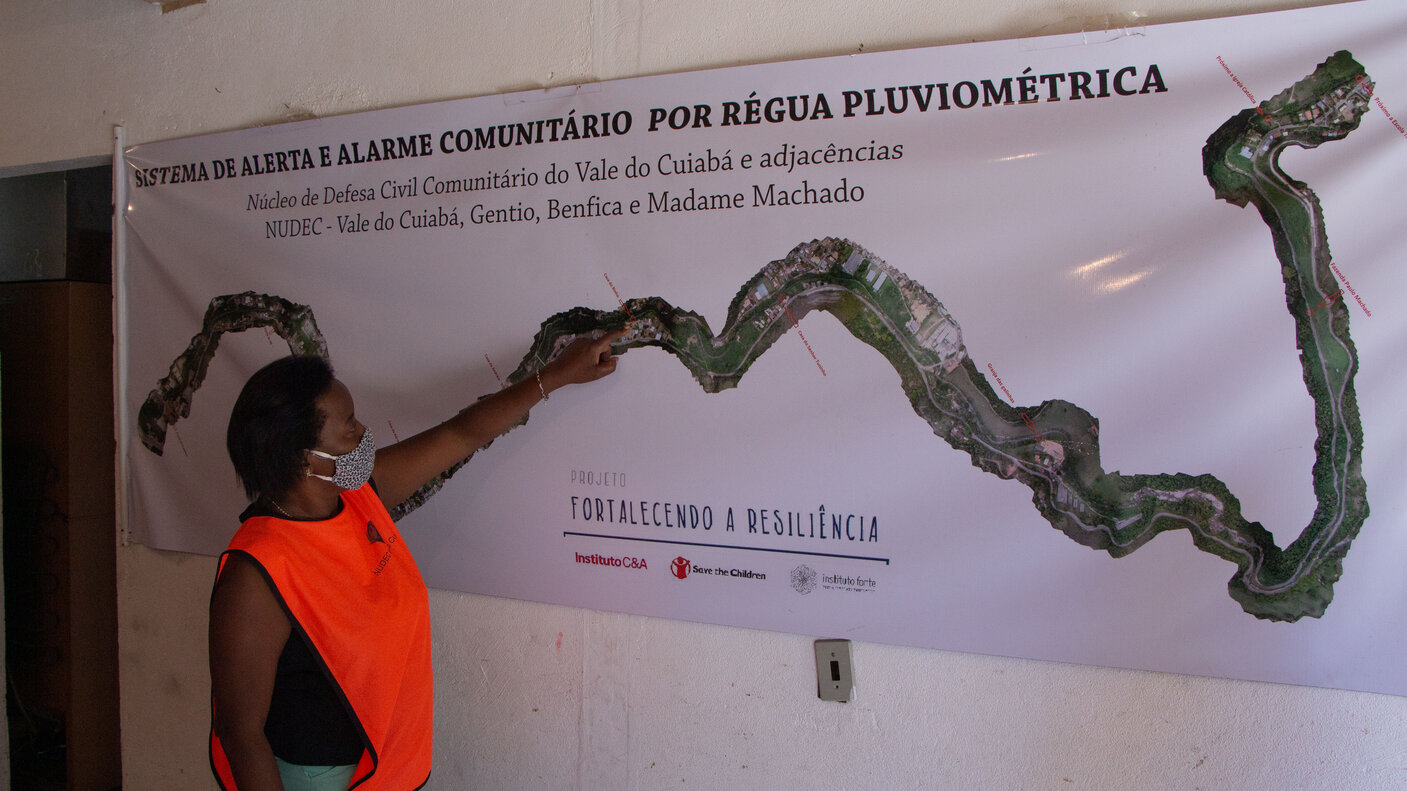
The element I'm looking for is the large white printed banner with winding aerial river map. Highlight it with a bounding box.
[118,3,1407,694]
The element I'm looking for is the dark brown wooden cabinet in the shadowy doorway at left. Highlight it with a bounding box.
[0,280,122,791]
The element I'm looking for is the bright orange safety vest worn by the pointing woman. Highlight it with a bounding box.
[210,484,435,791]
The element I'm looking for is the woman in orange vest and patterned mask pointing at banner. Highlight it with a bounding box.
[210,332,622,791]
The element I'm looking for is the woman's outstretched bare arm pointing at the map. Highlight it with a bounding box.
[373,331,625,508]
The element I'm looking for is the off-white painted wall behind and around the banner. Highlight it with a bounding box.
[0,0,1407,791]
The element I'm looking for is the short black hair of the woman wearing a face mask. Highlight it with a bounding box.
[225,356,332,500]
